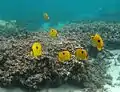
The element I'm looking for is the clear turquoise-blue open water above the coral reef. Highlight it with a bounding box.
[0,0,120,28]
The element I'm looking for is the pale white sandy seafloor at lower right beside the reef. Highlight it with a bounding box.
[105,50,120,92]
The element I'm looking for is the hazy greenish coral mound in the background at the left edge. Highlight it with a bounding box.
[0,20,27,38]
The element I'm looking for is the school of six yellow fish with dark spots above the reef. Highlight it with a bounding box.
[31,13,104,62]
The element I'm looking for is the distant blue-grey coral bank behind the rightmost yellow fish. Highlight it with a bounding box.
[62,21,120,49]
